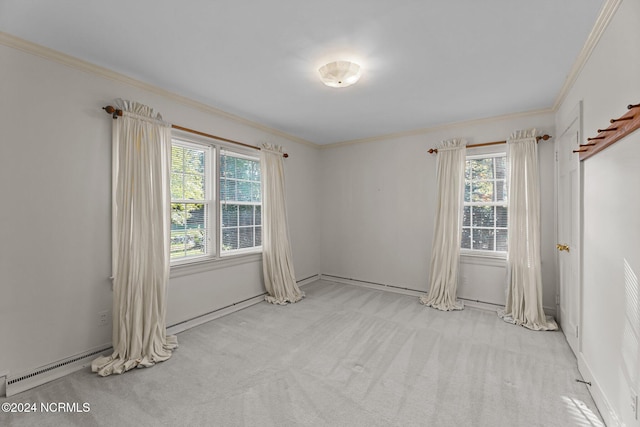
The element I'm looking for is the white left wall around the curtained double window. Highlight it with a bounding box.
[0,44,320,376]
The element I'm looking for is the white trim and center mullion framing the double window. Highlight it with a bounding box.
[169,129,262,270]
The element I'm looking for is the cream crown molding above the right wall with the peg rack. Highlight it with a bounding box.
[552,0,622,111]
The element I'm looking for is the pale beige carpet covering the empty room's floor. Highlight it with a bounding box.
[0,281,603,427]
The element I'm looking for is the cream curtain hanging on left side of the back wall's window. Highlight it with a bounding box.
[420,139,466,311]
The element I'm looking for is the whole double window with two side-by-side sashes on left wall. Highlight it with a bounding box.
[171,138,262,264]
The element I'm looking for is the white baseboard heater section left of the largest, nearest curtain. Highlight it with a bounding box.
[6,346,113,397]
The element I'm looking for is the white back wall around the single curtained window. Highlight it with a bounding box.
[320,109,557,313]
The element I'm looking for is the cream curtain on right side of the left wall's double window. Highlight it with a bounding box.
[260,144,304,305]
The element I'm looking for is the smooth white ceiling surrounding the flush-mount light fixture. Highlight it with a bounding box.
[0,0,605,144]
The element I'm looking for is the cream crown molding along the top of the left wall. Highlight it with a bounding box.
[0,31,319,148]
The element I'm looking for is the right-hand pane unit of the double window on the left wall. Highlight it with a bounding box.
[220,152,262,254]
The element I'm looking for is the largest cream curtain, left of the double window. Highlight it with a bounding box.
[91,100,177,376]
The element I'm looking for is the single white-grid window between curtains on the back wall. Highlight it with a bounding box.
[461,153,508,252]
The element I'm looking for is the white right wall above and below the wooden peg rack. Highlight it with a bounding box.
[556,0,640,426]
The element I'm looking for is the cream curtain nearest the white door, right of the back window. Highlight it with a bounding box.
[498,129,558,330]
